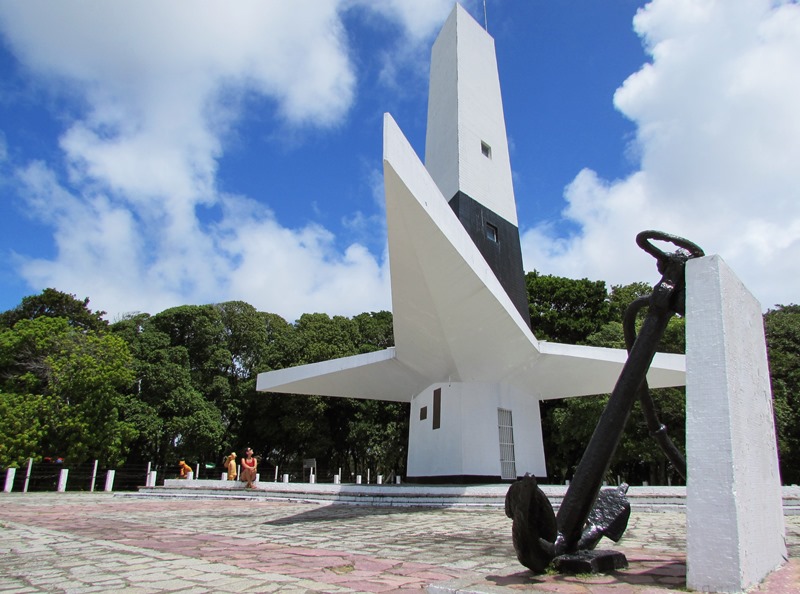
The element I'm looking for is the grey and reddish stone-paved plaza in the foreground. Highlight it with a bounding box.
[0,493,800,594]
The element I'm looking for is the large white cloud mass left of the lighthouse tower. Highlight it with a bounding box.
[0,0,450,319]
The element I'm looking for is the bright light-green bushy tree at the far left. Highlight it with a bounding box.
[0,316,135,464]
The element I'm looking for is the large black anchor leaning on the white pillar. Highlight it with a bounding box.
[505,231,704,573]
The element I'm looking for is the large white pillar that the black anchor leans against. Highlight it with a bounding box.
[686,256,787,592]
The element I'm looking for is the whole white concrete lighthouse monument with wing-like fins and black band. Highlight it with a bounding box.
[257,5,685,482]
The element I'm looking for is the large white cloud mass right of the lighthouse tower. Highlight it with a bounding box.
[523,0,800,308]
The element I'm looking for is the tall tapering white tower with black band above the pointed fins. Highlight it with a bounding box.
[425,4,530,325]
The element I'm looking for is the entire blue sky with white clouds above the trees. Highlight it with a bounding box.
[0,0,800,320]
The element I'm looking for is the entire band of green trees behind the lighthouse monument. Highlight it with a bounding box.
[0,284,800,484]
